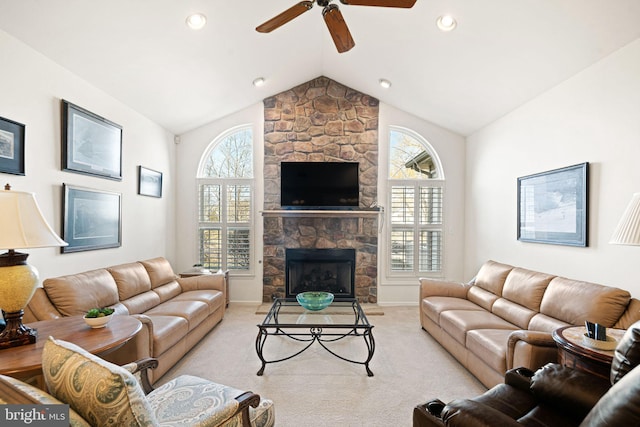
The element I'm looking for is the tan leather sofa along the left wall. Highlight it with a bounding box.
[24,257,227,381]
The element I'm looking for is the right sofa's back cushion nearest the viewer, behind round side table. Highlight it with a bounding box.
[540,277,631,328]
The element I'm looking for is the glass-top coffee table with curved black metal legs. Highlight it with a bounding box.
[256,298,375,377]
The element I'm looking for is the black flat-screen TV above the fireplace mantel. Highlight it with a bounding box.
[280,162,360,209]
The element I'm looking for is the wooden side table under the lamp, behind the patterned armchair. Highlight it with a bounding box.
[0,315,142,388]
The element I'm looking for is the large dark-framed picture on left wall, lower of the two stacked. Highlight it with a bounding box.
[62,184,122,253]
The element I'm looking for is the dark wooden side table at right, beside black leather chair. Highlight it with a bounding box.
[552,326,625,379]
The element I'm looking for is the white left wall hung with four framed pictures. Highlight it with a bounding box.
[0,31,175,279]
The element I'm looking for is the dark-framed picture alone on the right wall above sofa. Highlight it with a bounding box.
[518,163,589,246]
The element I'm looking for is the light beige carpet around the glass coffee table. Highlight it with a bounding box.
[156,303,486,427]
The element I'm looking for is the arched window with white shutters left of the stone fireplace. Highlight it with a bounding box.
[198,126,254,273]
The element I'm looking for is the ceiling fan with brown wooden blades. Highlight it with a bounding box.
[256,0,416,53]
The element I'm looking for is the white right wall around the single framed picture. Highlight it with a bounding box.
[465,40,640,297]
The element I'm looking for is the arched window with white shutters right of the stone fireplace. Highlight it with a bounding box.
[388,127,444,275]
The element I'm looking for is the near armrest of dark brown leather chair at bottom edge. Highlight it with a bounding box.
[442,399,521,427]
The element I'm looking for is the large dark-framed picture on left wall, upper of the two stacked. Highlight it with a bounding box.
[62,100,122,180]
